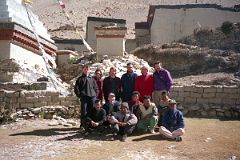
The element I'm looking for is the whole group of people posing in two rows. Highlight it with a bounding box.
[74,62,184,141]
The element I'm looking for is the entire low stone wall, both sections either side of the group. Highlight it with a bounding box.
[0,85,240,123]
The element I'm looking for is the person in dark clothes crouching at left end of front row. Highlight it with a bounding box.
[84,99,106,136]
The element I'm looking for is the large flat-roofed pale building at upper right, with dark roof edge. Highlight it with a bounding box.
[135,4,240,46]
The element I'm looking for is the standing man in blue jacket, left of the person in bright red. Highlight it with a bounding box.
[121,63,137,102]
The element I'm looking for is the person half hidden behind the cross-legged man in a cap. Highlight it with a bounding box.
[157,92,170,126]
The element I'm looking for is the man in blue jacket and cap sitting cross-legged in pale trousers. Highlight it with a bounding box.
[159,99,185,141]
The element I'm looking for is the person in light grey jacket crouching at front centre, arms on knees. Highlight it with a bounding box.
[110,102,138,141]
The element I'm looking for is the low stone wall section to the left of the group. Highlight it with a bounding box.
[0,90,80,123]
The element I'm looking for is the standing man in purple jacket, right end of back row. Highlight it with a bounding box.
[153,62,173,107]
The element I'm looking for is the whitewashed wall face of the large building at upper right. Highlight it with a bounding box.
[151,8,240,44]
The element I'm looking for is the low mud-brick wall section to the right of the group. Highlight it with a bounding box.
[170,85,240,119]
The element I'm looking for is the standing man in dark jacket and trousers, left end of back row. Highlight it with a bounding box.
[74,65,98,131]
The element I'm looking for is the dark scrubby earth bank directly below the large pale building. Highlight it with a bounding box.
[132,43,240,77]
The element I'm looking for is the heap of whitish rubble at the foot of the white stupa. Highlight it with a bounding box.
[0,59,69,94]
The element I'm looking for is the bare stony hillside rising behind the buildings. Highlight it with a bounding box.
[32,0,240,38]
